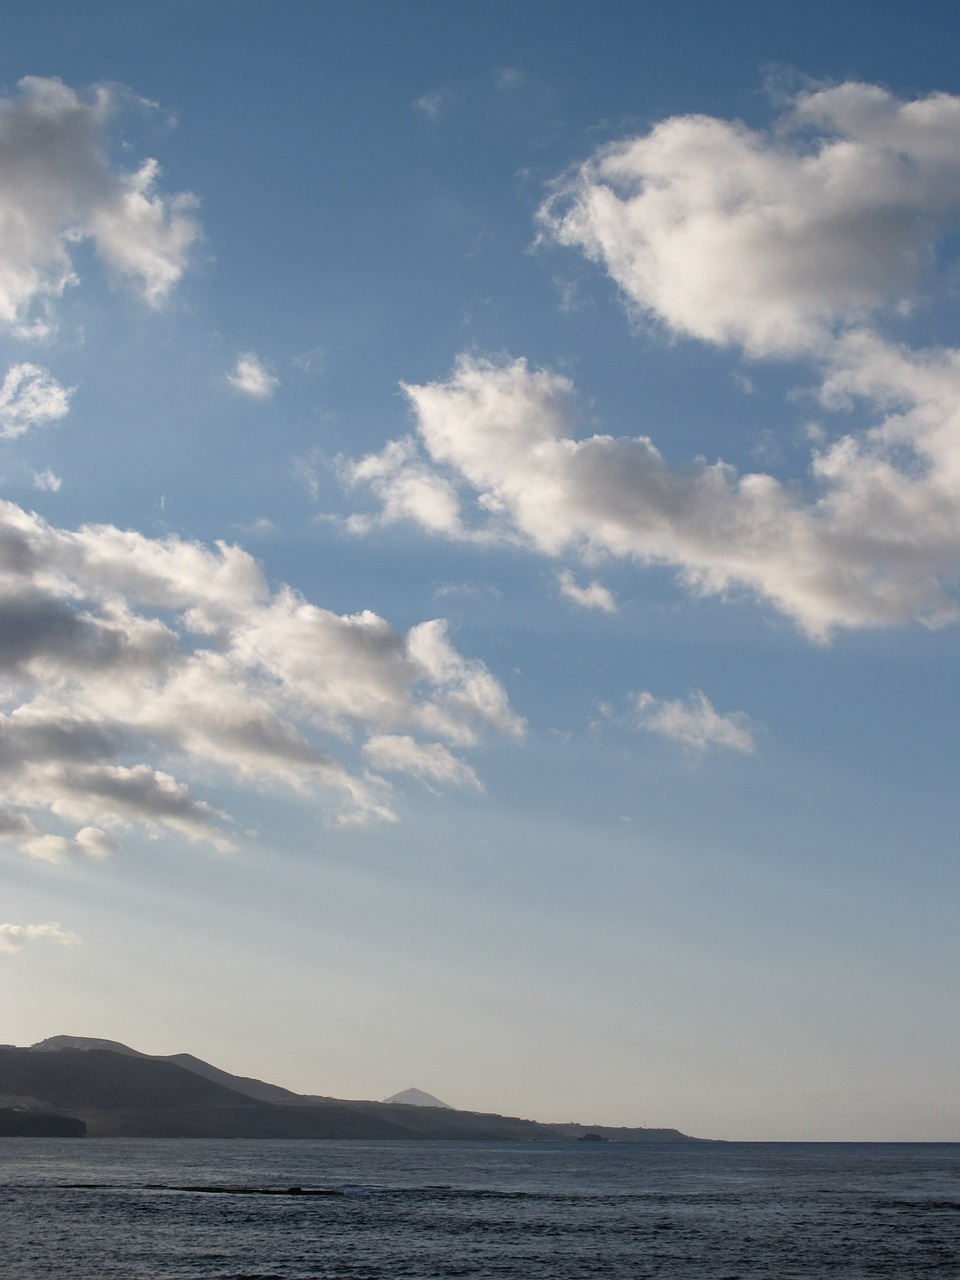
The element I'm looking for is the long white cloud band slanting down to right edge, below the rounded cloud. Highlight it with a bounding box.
[342,350,960,639]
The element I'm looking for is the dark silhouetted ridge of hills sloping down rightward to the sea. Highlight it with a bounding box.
[0,1037,696,1142]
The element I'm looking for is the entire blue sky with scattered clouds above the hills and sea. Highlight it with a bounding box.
[0,0,960,1140]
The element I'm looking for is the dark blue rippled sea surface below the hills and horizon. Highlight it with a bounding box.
[0,1138,960,1280]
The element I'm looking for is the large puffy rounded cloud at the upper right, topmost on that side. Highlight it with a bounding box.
[540,83,960,355]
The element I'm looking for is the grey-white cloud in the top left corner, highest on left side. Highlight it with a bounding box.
[0,76,200,338]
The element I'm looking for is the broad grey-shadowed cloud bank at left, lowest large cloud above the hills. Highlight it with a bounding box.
[0,503,522,861]
